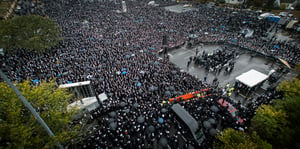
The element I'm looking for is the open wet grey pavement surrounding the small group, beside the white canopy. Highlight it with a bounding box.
[168,45,280,86]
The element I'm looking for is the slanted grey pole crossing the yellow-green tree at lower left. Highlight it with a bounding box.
[0,70,63,149]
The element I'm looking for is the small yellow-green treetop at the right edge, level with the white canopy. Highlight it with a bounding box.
[277,78,300,98]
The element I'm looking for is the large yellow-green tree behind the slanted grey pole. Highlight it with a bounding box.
[0,81,79,148]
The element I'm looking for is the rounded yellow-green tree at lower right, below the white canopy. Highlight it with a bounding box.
[250,105,291,146]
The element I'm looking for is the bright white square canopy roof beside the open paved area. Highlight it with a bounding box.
[235,69,268,87]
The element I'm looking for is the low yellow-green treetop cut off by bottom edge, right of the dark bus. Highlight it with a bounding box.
[214,128,272,149]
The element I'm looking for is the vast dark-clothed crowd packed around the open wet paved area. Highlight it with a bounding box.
[1,0,292,148]
